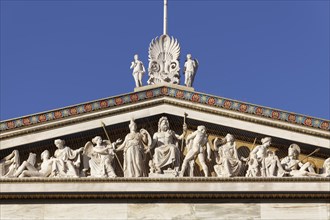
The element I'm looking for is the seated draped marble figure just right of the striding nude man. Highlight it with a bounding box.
[214,134,242,177]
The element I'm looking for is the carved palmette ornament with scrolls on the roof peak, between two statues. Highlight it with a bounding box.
[148,35,180,85]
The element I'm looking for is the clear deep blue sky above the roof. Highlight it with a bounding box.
[0,0,330,120]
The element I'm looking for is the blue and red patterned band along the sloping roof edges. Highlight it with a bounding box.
[0,86,330,131]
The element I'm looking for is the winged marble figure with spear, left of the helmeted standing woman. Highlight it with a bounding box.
[83,136,121,177]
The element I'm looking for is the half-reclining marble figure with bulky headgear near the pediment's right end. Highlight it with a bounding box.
[281,144,318,177]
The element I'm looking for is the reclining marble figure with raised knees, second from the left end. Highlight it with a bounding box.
[15,150,54,177]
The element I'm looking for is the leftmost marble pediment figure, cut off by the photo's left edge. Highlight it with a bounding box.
[0,150,20,177]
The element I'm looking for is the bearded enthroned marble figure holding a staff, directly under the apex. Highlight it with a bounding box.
[149,117,187,174]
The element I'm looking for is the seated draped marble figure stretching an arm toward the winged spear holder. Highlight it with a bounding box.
[53,139,83,177]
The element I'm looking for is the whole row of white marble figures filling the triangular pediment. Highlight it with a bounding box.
[0,117,330,178]
